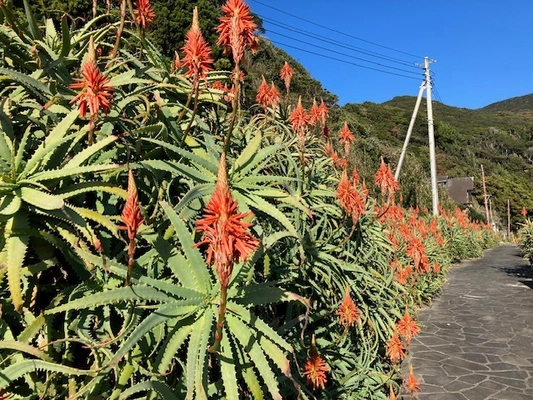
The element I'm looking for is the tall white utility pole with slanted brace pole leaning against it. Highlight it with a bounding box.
[394,57,439,215]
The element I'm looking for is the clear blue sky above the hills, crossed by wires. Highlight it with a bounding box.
[247,0,533,109]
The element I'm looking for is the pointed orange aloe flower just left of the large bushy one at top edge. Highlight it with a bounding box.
[181,7,213,80]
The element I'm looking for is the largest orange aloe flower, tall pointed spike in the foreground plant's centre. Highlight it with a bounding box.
[195,153,259,287]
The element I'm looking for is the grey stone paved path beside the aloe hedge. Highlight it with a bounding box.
[402,244,533,400]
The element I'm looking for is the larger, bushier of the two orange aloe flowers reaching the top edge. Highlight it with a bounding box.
[217,0,259,65]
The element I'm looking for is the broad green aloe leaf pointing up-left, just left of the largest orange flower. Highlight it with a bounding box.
[160,202,211,292]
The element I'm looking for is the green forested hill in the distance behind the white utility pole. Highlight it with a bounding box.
[343,95,533,227]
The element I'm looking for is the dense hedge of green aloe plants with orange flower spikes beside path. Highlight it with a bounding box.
[0,0,495,399]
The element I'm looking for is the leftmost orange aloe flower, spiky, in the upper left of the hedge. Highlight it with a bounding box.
[69,57,113,118]
